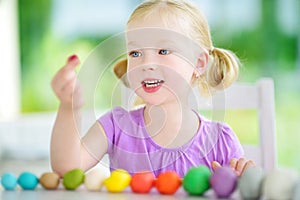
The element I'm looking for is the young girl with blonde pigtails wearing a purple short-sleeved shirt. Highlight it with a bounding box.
[51,0,254,177]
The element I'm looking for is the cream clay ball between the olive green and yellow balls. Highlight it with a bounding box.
[84,168,108,191]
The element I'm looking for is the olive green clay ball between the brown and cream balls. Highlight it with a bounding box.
[63,168,84,190]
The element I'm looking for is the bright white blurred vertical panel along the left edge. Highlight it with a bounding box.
[0,0,20,121]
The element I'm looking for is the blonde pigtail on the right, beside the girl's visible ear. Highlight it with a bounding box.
[205,48,239,90]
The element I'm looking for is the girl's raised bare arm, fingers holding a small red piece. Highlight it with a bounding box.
[50,56,107,176]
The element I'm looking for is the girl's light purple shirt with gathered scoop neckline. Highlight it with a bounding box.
[98,107,243,177]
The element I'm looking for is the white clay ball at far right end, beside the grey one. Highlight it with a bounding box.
[262,169,299,200]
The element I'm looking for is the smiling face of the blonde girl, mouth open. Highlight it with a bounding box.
[126,15,203,105]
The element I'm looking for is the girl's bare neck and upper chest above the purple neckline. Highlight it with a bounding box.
[144,101,199,147]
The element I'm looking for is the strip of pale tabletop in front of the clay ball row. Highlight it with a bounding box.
[0,187,240,200]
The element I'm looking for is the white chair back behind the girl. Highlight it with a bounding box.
[122,78,277,171]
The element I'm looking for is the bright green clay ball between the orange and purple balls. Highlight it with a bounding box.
[182,166,211,195]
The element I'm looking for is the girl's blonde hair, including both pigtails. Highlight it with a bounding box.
[114,0,239,95]
